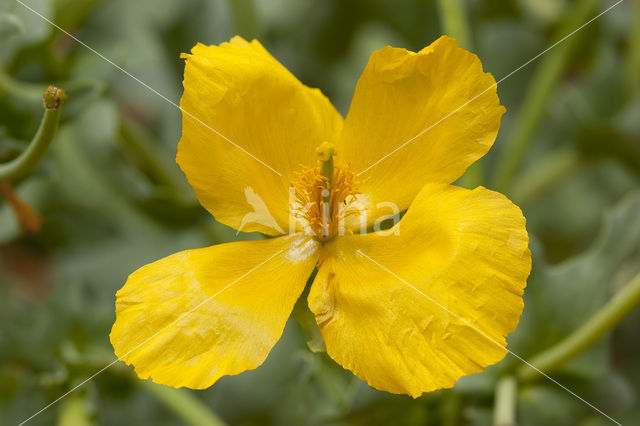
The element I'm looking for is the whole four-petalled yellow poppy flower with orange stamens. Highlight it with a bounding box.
[111,37,531,397]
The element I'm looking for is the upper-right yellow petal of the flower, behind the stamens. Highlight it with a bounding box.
[337,36,505,223]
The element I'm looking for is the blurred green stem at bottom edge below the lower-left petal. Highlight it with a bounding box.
[140,380,226,426]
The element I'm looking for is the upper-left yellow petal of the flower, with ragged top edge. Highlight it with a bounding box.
[177,37,342,235]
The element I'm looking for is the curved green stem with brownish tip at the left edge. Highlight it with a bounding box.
[0,86,66,180]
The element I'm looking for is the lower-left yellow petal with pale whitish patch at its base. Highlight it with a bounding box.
[110,235,317,389]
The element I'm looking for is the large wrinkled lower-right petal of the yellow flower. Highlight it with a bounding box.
[308,184,531,397]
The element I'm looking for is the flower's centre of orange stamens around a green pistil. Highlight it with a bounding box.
[291,142,360,241]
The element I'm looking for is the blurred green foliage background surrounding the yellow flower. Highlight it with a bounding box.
[0,0,640,426]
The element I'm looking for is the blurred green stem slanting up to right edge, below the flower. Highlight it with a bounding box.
[518,274,640,380]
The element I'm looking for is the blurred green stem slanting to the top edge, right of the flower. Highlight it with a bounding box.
[492,0,597,192]
